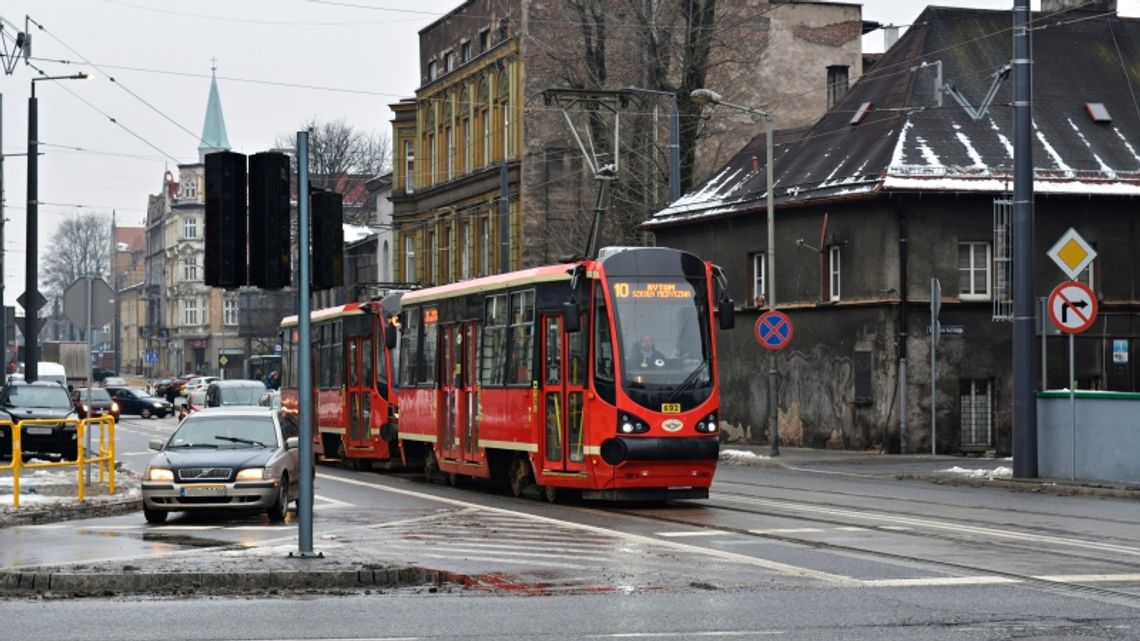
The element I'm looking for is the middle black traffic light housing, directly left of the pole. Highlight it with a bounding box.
[250,152,292,290]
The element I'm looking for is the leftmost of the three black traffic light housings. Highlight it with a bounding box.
[205,152,246,289]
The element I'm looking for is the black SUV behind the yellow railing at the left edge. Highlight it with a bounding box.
[0,381,79,461]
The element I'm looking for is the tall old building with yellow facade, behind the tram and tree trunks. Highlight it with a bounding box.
[391,0,863,284]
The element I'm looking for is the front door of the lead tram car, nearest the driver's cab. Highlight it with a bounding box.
[542,315,586,472]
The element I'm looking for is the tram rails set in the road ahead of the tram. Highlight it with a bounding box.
[606,492,1140,609]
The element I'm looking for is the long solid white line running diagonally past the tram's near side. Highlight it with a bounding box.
[317,474,858,586]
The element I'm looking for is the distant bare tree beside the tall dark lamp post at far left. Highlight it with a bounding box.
[40,213,111,299]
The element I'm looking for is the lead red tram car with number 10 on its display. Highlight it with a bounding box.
[396,248,733,501]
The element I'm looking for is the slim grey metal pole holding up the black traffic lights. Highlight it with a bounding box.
[296,131,320,558]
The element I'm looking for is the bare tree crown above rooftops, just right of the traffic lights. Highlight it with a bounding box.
[275,116,392,188]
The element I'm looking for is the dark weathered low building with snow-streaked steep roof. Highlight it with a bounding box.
[646,0,1140,454]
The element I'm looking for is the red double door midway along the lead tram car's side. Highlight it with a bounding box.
[440,324,479,461]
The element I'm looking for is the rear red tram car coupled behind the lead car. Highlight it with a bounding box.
[282,294,402,469]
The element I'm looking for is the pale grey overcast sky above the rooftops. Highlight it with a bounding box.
[0,0,1140,315]
